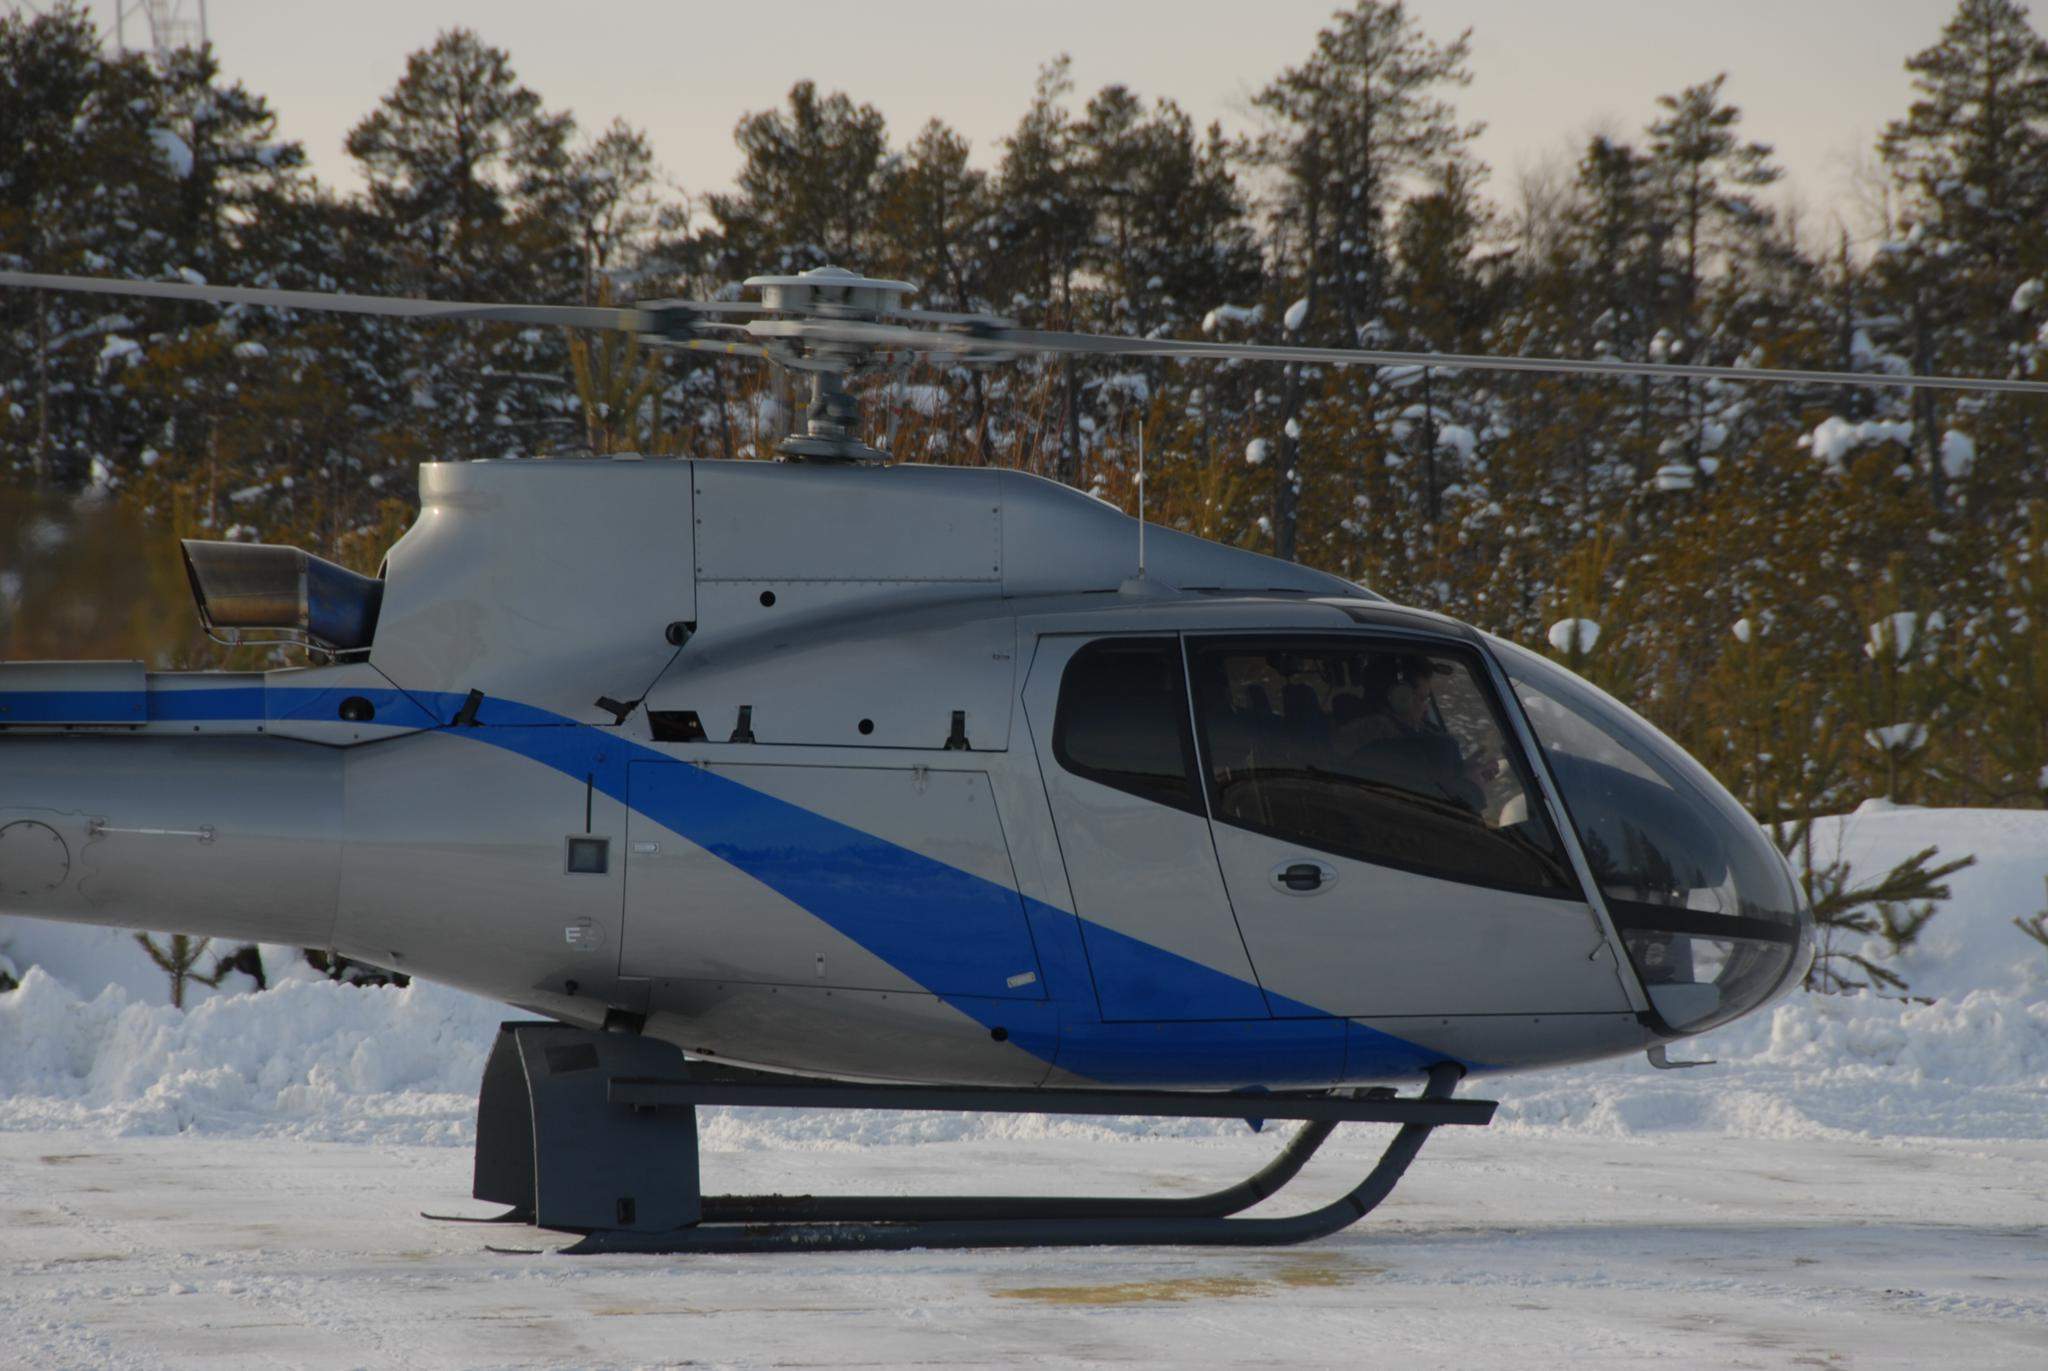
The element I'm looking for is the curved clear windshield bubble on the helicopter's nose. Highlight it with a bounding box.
[1491,639,1812,1033]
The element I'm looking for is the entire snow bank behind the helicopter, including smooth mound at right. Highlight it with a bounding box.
[0,819,2048,1152]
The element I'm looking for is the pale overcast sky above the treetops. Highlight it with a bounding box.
[94,0,1956,239]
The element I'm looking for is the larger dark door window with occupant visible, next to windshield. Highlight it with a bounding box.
[1190,639,1579,896]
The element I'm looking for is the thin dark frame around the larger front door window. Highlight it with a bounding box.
[1182,627,1587,904]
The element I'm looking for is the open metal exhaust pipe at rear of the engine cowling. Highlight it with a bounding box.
[180,539,383,652]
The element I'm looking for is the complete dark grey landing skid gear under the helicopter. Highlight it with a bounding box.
[456,1023,1495,1254]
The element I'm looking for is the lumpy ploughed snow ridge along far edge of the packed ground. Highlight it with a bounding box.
[0,969,2048,1152]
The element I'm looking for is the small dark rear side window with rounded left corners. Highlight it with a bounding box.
[1053,637,1202,814]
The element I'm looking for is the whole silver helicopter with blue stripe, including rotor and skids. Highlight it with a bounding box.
[0,268,2048,1250]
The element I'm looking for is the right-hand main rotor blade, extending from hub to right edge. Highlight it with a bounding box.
[991,328,2048,396]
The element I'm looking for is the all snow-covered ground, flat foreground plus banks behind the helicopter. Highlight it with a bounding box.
[0,809,2048,1371]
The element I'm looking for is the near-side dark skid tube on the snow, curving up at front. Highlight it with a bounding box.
[563,1062,1466,1254]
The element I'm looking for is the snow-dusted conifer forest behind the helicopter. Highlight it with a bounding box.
[0,0,2048,848]
